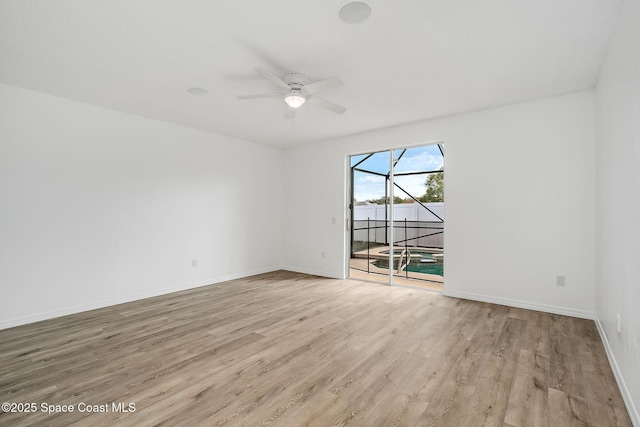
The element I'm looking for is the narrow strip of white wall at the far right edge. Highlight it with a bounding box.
[595,0,640,426]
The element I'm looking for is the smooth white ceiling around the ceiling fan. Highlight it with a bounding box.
[0,0,622,147]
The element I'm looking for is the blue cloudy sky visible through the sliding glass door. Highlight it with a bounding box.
[351,145,444,202]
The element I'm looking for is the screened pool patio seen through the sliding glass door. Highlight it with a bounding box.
[349,144,444,290]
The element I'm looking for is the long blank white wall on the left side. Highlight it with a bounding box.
[0,85,282,327]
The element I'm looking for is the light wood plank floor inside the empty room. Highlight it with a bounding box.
[0,272,631,426]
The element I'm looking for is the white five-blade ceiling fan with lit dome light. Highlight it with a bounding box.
[238,68,347,114]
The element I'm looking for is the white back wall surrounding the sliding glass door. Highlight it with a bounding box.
[284,91,595,317]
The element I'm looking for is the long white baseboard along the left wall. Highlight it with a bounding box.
[0,267,281,330]
